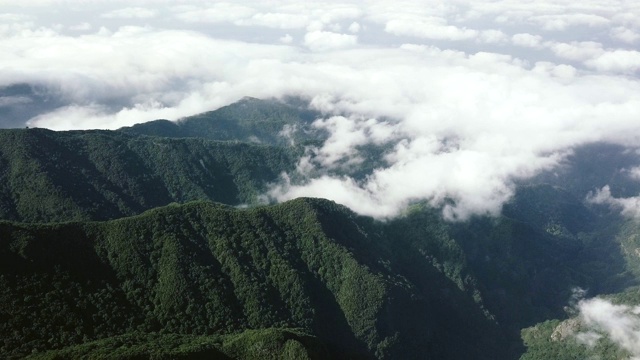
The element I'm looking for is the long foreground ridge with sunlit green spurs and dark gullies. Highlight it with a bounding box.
[0,199,506,359]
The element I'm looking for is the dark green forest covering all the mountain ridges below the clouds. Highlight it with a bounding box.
[0,99,640,359]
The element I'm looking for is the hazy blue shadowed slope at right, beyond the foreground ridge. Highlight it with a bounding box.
[452,185,638,335]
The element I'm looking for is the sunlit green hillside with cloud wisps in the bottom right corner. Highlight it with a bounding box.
[522,219,640,360]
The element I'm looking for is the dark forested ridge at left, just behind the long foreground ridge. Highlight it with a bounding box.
[0,129,301,222]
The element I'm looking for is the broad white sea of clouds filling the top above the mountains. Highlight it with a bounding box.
[0,0,640,220]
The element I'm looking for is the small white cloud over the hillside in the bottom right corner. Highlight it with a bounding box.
[578,298,640,359]
